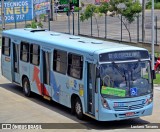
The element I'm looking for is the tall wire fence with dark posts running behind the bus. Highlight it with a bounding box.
[0,11,160,45]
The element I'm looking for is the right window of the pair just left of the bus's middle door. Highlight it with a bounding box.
[30,44,40,66]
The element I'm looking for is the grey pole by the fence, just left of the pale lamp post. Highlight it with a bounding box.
[142,0,146,43]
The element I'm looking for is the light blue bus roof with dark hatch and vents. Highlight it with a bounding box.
[3,28,146,54]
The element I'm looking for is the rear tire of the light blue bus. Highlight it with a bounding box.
[22,77,31,97]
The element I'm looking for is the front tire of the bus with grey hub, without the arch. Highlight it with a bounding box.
[74,97,84,120]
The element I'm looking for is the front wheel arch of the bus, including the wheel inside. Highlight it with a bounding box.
[71,94,84,120]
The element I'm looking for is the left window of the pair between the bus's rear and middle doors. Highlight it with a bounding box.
[21,42,29,62]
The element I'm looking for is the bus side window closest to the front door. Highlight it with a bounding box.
[68,54,83,79]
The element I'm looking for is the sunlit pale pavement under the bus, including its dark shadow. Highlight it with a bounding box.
[0,48,160,132]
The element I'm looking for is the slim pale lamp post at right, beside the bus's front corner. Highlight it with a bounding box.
[151,0,156,79]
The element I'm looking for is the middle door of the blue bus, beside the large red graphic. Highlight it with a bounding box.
[41,50,52,99]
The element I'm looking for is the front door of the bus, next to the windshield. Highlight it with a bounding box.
[87,63,98,116]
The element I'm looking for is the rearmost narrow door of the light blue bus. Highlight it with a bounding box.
[12,42,20,83]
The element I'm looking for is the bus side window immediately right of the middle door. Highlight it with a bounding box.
[53,50,67,74]
